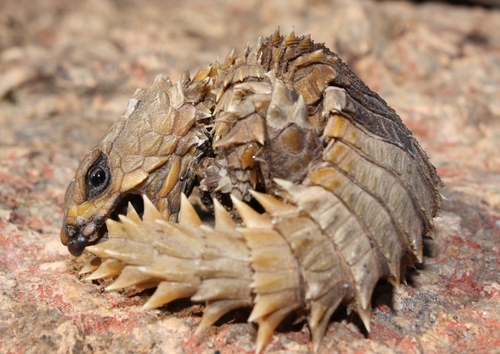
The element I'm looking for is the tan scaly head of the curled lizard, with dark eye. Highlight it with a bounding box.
[61,76,206,256]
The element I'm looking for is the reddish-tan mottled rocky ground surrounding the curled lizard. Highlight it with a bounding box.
[0,0,500,353]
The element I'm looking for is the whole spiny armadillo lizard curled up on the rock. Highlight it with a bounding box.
[61,31,442,351]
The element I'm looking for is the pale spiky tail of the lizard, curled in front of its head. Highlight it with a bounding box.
[87,192,350,352]
